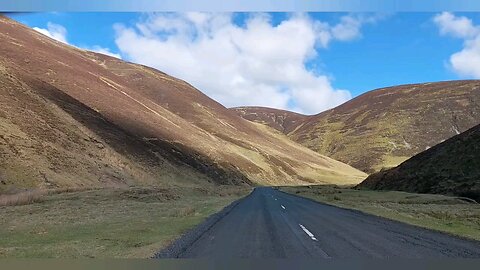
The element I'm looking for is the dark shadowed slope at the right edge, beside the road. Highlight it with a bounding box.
[359,125,480,200]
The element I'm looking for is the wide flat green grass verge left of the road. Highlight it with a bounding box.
[0,187,250,258]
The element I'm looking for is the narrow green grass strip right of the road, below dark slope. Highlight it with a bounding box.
[280,186,480,240]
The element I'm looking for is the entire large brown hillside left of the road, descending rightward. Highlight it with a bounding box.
[0,17,365,190]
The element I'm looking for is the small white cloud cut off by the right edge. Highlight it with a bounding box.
[433,12,480,79]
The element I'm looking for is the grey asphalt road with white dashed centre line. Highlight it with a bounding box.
[179,188,480,259]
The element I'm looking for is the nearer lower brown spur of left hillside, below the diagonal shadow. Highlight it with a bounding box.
[0,66,221,192]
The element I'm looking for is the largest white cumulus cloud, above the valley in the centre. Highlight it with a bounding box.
[114,13,371,114]
